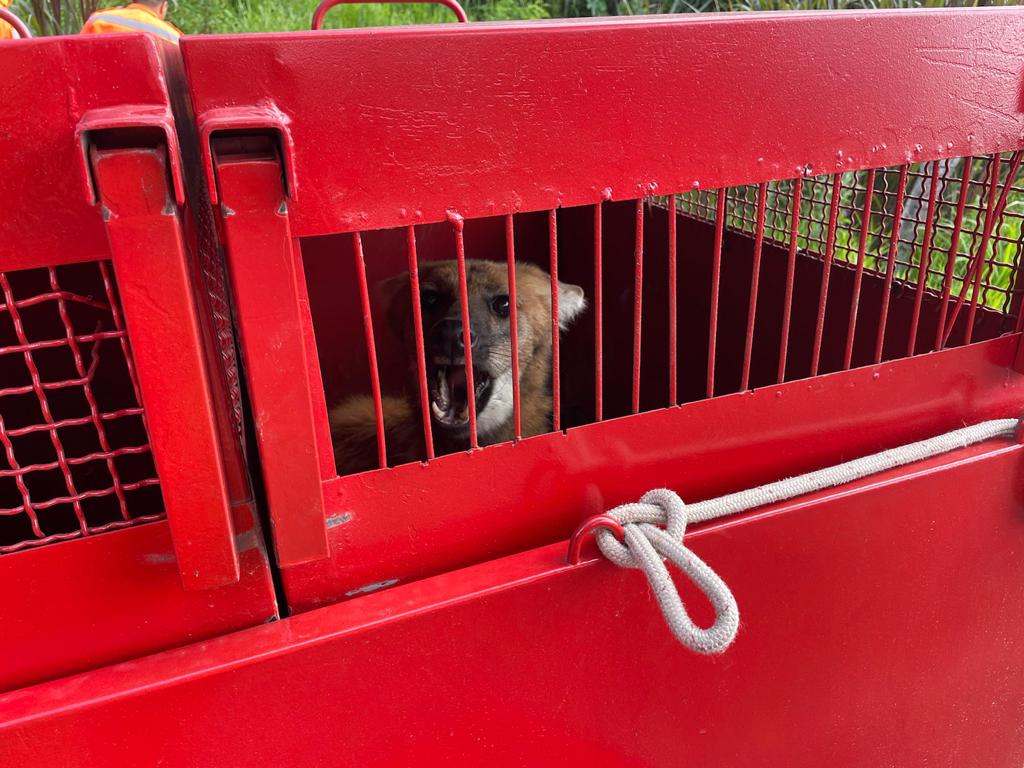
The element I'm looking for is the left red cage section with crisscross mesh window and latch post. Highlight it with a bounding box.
[0,36,276,689]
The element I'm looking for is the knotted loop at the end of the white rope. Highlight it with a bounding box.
[597,488,739,653]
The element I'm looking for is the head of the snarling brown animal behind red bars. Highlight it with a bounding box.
[386,259,586,439]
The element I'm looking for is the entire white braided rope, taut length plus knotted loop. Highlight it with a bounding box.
[597,419,1019,653]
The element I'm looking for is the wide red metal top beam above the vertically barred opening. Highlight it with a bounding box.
[182,8,1024,237]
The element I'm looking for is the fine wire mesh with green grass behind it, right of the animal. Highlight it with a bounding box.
[680,153,1024,335]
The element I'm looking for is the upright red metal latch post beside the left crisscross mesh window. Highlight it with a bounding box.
[84,128,239,590]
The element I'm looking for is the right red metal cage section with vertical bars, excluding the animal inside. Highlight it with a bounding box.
[183,12,1021,609]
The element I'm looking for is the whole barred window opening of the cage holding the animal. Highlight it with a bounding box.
[303,152,1024,471]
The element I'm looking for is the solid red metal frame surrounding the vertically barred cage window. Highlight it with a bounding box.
[182,10,1024,609]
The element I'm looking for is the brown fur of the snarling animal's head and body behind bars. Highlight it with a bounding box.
[331,259,586,474]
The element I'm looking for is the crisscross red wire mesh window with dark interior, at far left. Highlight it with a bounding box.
[0,262,164,553]
